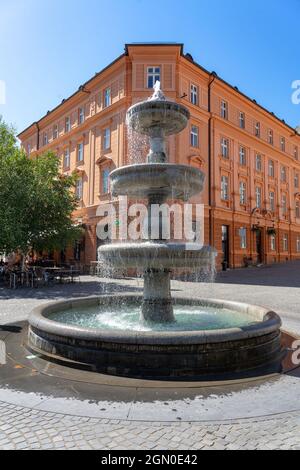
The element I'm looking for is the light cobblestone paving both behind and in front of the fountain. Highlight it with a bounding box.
[0,263,300,450]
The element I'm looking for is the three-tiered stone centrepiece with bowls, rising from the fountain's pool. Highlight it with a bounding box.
[99,82,216,323]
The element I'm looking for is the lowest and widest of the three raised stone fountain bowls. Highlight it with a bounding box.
[99,241,217,271]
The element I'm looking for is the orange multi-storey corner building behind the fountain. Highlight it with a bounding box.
[19,44,300,268]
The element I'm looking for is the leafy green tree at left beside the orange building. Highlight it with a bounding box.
[0,118,82,255]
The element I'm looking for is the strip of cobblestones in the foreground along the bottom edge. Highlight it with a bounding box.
[0,402,300,450]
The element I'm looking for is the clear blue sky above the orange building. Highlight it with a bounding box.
[0,0,300,131]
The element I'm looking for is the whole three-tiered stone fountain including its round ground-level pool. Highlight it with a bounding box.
[28,85,282,380]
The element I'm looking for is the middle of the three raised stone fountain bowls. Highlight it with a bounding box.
[110,163,205,201]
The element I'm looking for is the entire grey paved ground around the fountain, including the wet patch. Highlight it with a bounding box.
[0,263,300,450]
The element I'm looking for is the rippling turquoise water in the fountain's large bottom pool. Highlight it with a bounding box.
[49,305,255,331]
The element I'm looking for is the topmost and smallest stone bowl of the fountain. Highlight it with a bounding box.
[127,100,190,137]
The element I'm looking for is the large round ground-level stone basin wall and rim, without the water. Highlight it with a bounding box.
[28,295,283,380]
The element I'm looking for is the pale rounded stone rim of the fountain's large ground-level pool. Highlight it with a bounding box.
[29,294,282,345]
